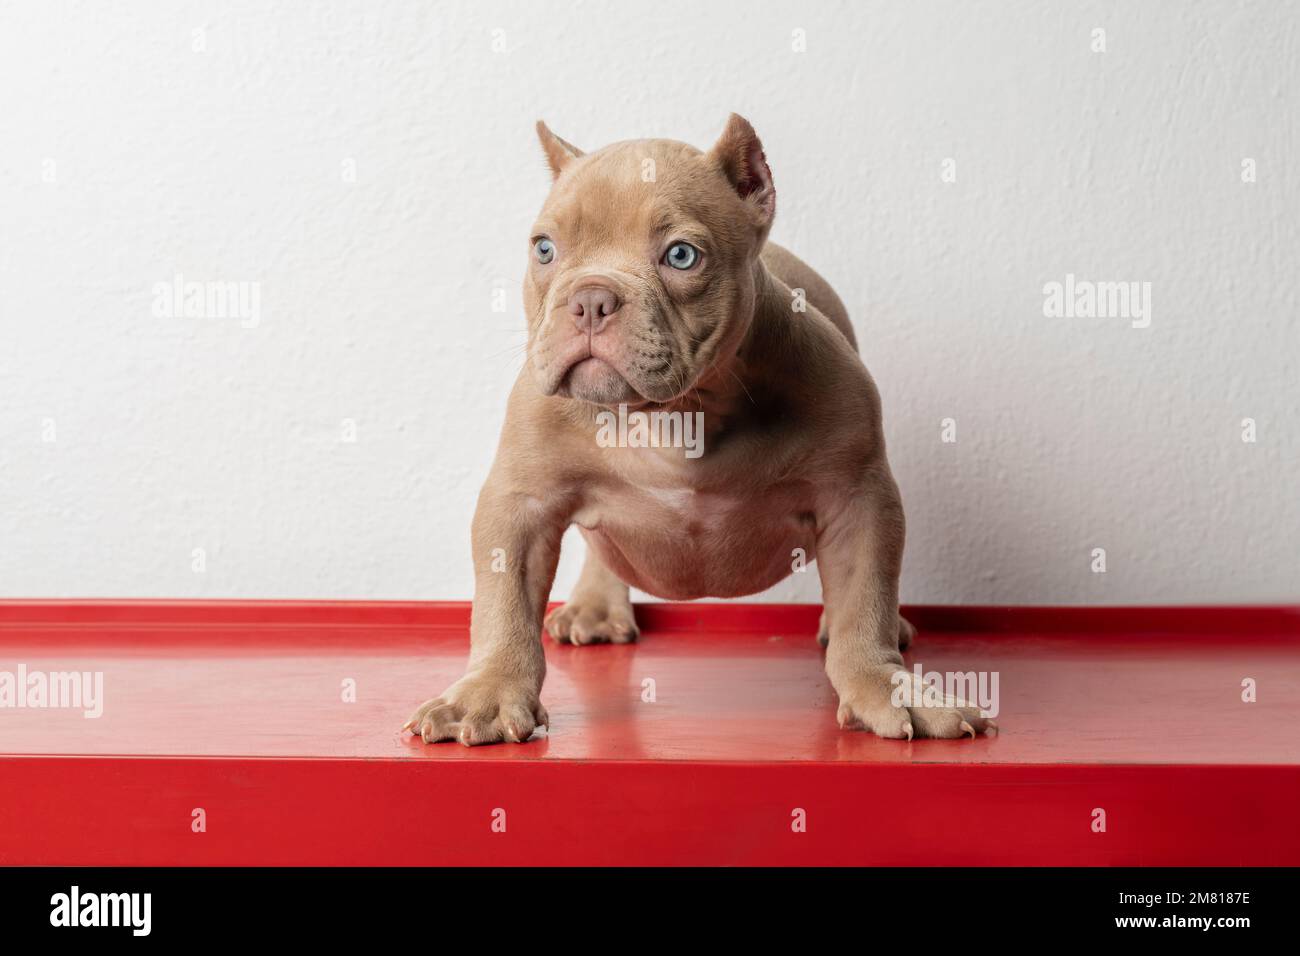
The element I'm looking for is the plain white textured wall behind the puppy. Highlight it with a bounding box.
[0,0,1300,604]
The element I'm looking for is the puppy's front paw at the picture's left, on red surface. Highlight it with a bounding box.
[402,675,550,747]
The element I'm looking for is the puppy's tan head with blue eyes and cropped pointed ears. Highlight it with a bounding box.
[524,114,776,406]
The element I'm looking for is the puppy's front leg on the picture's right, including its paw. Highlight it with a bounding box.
[818,463,989,740]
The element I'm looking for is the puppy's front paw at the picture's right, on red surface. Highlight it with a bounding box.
[832,665,997,740]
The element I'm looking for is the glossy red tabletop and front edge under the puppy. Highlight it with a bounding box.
[0,602,1300,865]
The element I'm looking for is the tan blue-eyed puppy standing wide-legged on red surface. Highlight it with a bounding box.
[403,114,991,745]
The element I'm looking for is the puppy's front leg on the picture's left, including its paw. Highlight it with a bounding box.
[403,468,568,747]
